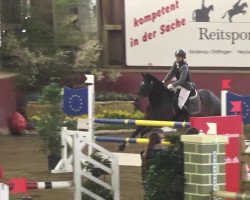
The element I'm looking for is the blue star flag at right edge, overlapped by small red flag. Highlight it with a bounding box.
[226,92,250,124]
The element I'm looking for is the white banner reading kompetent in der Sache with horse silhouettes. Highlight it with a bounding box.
[124,0,250,67]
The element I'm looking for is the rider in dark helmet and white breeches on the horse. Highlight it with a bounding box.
[162,49,194,113]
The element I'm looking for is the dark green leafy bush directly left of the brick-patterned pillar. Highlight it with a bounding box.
[143,135,185,200]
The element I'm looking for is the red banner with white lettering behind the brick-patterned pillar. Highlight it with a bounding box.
[190,115,243,192]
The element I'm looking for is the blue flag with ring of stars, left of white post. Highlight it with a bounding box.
[63,87,88,116]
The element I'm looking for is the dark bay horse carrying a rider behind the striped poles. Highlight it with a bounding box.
[119,73,221,151]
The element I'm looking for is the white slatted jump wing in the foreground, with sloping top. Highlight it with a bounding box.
[73,134,120,200]
